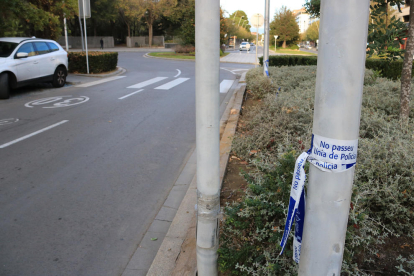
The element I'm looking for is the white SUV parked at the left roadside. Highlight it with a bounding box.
[0,37,68,99]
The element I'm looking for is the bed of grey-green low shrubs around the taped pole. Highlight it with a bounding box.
[219,66,414,276]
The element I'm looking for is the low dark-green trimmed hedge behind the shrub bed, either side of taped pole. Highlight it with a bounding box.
[259,56,414,80]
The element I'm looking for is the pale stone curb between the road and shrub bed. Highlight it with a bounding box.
[147,84,246,276]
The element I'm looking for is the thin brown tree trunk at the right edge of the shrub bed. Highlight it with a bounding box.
[400,1,414,123]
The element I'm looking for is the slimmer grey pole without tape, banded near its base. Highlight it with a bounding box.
[195,0,220,276]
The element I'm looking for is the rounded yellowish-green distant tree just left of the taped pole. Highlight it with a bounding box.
[270,6,299,48]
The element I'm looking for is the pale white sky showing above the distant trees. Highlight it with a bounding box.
[220,0,306,33]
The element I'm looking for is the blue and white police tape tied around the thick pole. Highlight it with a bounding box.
[280,134,358,263]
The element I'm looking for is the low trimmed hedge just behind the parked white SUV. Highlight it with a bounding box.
[68,52,118,74]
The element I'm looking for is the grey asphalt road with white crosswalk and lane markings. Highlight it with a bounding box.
[0,53,253,276]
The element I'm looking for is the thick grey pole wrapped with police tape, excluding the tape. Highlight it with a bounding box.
[299,0,369,276]
